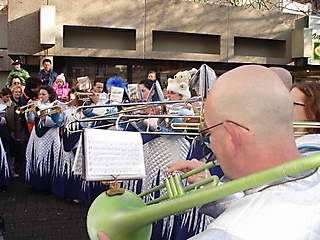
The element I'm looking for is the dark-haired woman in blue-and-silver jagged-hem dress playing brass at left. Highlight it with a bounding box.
[25,85,63,192]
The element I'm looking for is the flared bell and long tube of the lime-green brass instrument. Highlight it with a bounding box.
[87,153,320,240]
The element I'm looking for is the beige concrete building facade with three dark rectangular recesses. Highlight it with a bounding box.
[3,0,301,86]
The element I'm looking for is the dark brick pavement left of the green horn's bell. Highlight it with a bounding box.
[0,179,89,240]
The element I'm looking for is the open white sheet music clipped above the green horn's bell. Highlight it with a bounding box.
[83,129,145,181]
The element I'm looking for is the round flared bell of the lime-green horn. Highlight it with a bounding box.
[87,190,152,240]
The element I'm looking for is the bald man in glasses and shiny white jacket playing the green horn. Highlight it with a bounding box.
[98,65,320,240]
